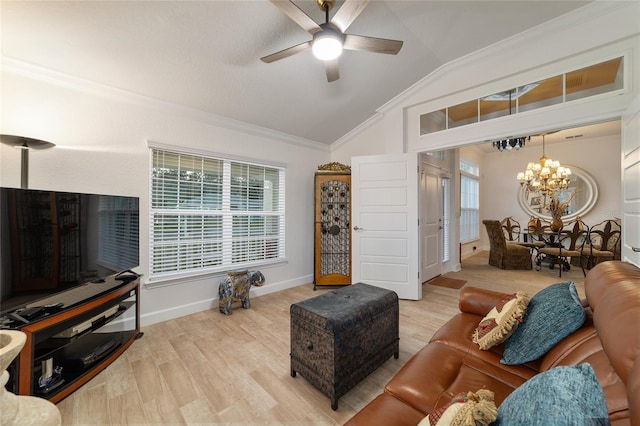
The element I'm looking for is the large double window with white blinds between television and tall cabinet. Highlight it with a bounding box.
[149,149,285,277]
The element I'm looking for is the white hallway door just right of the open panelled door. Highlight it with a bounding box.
[420,166,443,282]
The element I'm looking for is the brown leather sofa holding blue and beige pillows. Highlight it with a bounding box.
[347,261,640,426]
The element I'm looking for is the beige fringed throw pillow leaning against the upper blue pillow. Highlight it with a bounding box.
[473,292,530,350]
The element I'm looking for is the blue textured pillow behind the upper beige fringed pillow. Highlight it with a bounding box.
[500,281,586,365]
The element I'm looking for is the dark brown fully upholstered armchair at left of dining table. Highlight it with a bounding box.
[482,220,532,269]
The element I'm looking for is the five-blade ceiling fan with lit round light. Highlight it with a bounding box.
[260,0,403,82]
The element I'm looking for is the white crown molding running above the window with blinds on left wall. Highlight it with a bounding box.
[0,55,329,152]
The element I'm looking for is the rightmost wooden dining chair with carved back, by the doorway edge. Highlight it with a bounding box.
[583,219,622,269]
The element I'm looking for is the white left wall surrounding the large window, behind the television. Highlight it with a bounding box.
[0,68,329,324]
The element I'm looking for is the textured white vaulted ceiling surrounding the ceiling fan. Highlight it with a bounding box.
[0,0,587,144]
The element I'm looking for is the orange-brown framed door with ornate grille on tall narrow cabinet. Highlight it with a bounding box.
[314,174,351,285]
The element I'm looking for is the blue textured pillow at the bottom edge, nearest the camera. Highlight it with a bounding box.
[493,364,610,426]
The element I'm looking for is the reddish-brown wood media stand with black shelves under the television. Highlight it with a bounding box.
[8,277,141,403]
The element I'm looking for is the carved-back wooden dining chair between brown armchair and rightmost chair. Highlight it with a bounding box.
[536,220,589,277]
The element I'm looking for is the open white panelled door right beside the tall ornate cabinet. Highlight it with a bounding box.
[351,154,422,300]
